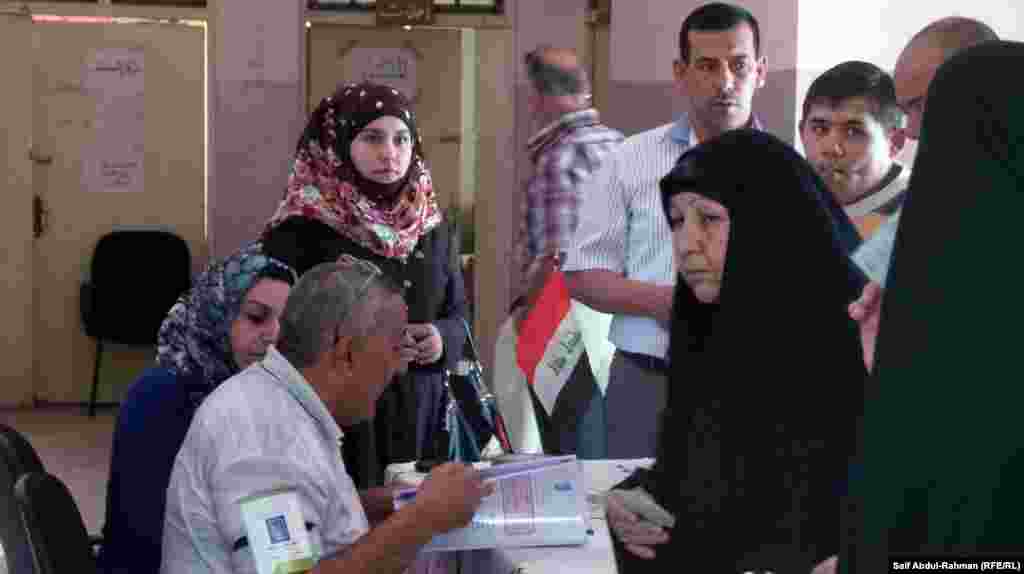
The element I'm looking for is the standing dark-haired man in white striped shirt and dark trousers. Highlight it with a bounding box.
[562,3,766,458]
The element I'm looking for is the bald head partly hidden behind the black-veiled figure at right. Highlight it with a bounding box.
[894,16,999,139]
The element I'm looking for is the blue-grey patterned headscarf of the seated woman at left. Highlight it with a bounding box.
[157,241,295,389]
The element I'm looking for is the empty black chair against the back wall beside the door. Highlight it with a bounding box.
[81,229,191,416]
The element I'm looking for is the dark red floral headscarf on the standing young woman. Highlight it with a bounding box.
[265,83,441,260]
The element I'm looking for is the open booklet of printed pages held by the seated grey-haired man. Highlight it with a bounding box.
[395,456,588,551]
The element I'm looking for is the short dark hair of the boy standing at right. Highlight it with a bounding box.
[803,60,903,129]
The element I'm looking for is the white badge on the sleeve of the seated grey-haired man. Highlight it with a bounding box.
[239,489,316,574]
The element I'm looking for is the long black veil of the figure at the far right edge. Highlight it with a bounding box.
[855,42,1024,572]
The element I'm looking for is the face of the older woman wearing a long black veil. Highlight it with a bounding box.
[669,192,729,303]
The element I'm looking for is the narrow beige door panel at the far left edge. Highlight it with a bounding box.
[0,14,33,406]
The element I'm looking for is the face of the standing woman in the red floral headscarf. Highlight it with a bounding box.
[349,116,413,184]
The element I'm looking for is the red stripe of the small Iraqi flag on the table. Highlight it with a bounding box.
[516,270,569,385]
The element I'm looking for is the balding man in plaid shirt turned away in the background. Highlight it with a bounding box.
[516,46,624,304]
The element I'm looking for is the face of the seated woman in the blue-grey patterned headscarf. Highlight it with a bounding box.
[231,278,291,368]
